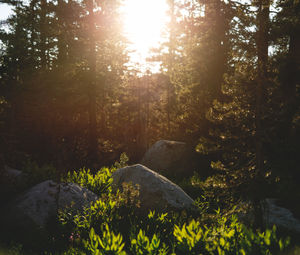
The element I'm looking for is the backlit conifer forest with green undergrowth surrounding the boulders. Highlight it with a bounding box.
[0,0,300,255]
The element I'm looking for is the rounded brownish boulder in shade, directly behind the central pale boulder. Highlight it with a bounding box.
[141,140,206,178]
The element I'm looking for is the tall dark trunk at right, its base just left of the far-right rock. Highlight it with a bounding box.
[253,0,270,228]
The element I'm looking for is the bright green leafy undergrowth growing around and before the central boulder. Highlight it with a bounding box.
[56,169,289,255]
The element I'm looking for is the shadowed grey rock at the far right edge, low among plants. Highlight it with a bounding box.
[263,198,300,234]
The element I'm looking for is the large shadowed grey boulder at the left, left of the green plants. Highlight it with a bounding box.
[3,180,98,246]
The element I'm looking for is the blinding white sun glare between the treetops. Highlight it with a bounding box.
[123,0,168,70]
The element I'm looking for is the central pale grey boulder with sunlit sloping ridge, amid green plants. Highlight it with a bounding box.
[112,164,194,211]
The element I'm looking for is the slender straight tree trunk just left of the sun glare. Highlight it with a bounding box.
[87,0,98,163]
